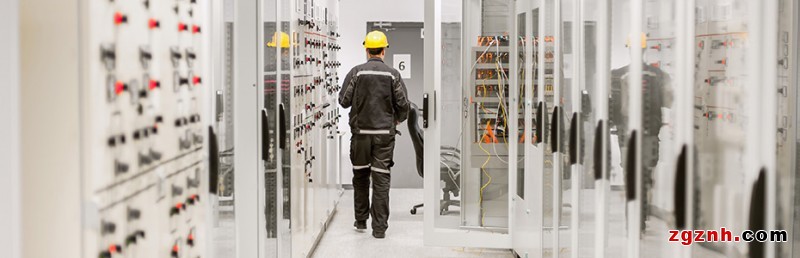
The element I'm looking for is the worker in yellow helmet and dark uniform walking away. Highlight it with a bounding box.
[339,31,409,239]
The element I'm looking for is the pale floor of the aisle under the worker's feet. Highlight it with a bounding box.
[314,189,514,258]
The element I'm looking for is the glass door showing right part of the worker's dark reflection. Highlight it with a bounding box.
[639,0,680,257]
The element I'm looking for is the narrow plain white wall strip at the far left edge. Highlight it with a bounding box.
[0,0,21,258]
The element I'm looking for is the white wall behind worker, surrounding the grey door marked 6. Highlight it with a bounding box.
[337,0,425,184]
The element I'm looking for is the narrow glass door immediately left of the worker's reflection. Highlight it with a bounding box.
[570,0,604,257]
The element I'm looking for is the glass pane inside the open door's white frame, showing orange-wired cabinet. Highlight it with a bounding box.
[444,1,517,232]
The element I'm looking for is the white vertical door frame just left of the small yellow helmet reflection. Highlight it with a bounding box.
[233,0,263,257]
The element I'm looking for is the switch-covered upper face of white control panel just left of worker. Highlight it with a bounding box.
[288,1,341,183]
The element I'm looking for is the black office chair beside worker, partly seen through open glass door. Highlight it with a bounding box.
[408,103,461,215]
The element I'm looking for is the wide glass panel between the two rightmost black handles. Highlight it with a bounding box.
[692,0,760,257]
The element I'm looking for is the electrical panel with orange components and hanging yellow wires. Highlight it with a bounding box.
[461,36,524,229]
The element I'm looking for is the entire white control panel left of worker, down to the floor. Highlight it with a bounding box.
[279,0,341,257]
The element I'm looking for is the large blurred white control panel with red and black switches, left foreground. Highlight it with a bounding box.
[81,0,210,258]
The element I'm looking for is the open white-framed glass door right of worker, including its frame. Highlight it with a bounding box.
[422,0,522,248]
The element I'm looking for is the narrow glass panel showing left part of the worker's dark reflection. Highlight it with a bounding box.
[602,0,638,257]
